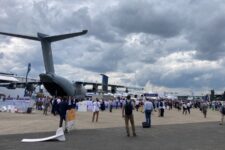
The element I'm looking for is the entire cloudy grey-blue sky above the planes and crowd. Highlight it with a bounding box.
[0,0,225,94]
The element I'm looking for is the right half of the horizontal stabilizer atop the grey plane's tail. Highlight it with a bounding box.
[44,30,88,42]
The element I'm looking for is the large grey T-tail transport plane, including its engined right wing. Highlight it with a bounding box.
[0,30,143,98]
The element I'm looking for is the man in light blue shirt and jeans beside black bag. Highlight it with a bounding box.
[144,99,153,127]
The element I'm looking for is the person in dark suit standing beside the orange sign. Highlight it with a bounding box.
[59,97,69,133]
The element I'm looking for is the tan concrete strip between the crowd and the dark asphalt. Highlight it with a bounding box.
[0,109,220,135]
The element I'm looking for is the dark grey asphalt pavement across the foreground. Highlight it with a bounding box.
[0,122,225,150]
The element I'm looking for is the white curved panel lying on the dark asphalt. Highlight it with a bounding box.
[21,128,66,142]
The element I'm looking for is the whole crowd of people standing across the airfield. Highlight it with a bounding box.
[33,95,225,137]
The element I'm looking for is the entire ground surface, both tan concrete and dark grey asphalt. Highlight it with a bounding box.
[0,109,225,150]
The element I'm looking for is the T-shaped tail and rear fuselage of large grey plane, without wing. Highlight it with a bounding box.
[0,30,87,97]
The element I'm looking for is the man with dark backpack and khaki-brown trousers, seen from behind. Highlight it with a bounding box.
[122,95,136,137]
